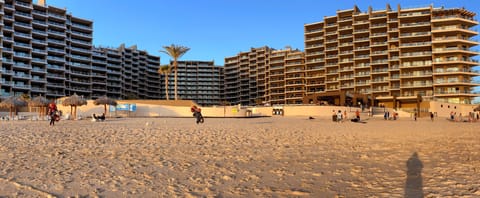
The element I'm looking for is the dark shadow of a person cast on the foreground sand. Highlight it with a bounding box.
[404,152,424,198]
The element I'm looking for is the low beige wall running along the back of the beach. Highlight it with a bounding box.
[7,100,476,118]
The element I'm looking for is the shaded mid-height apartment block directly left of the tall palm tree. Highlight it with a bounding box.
[91,44,161,99]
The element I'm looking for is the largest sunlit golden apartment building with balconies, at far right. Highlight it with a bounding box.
[304,5,479,107]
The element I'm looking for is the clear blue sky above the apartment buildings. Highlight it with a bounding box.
[47,0,480,65]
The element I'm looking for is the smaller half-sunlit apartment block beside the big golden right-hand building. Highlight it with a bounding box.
[225,47,305,105]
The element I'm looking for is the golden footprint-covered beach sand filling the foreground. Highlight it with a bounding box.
[0,117,480,197]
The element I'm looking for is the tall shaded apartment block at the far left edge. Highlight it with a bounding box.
[0,0,92,98]
